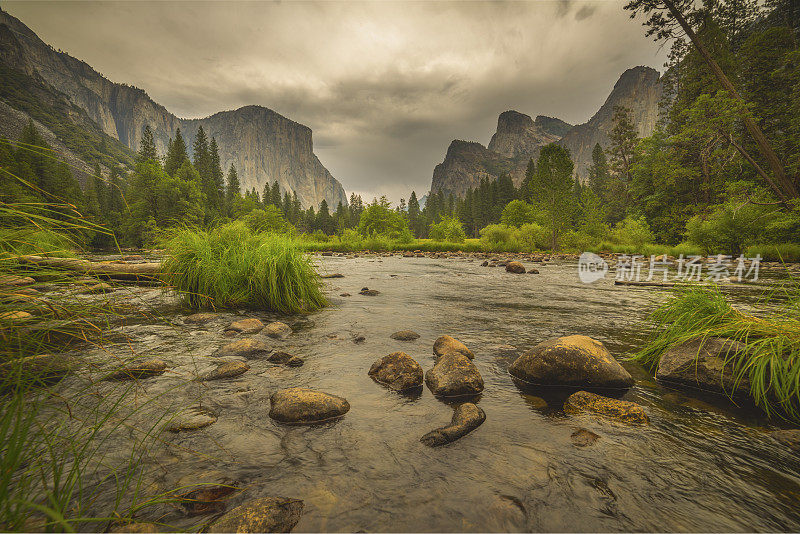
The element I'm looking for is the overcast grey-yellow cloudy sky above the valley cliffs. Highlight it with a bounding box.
[2,0,665,201]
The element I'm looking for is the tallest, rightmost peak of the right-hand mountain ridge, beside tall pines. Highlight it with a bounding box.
[559,67,663,179]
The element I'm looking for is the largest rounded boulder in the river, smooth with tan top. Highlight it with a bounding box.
[508,335,633,388]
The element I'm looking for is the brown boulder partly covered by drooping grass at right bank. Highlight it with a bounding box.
[656,337,750,397]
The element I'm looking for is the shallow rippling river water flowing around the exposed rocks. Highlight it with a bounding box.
[57,256,800,532]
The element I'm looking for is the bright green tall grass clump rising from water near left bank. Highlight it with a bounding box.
[162,222,326,313]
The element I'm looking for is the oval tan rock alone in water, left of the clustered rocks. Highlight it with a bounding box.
[269,388,350,424]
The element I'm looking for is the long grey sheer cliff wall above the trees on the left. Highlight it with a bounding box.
[0,11,347,209]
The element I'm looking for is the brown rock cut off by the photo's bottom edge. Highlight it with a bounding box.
[206,497,303,533]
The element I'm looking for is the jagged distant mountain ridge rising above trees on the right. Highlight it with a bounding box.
[431,66,662,197]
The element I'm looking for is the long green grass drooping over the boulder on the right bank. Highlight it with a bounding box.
[633,284,800,421]
